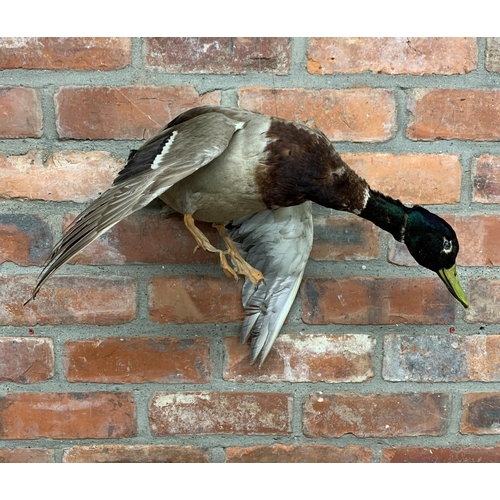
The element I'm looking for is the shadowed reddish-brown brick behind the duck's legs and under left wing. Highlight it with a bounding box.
[63,213,219,266]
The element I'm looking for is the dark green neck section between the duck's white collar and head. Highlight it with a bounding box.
[359,190,411,242]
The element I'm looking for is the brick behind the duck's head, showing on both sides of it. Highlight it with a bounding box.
[388,215,500,266]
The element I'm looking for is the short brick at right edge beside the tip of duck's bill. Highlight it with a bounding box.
[465,278,500,323]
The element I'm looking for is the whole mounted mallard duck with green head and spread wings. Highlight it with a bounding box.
[29,106,468,364]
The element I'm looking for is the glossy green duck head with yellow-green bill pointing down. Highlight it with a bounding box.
[403,206,469,307]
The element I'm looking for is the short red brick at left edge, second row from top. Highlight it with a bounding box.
[0,87,43,139]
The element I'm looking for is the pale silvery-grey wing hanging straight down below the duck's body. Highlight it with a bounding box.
[228,201,313,366]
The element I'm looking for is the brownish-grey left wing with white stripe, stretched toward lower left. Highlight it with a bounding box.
[28,107,245,302]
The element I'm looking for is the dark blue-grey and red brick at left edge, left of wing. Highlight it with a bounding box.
[0,214,54,266]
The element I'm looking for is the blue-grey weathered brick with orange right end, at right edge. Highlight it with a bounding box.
[382,334,500,382]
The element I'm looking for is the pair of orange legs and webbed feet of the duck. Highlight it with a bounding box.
[184,214,264,286]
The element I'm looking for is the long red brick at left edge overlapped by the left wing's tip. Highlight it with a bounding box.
[0,275,137,326]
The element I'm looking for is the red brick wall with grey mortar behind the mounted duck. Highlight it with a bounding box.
[0,38,500,462]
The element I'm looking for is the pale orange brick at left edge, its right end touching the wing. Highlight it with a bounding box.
[0,151,123,202]
